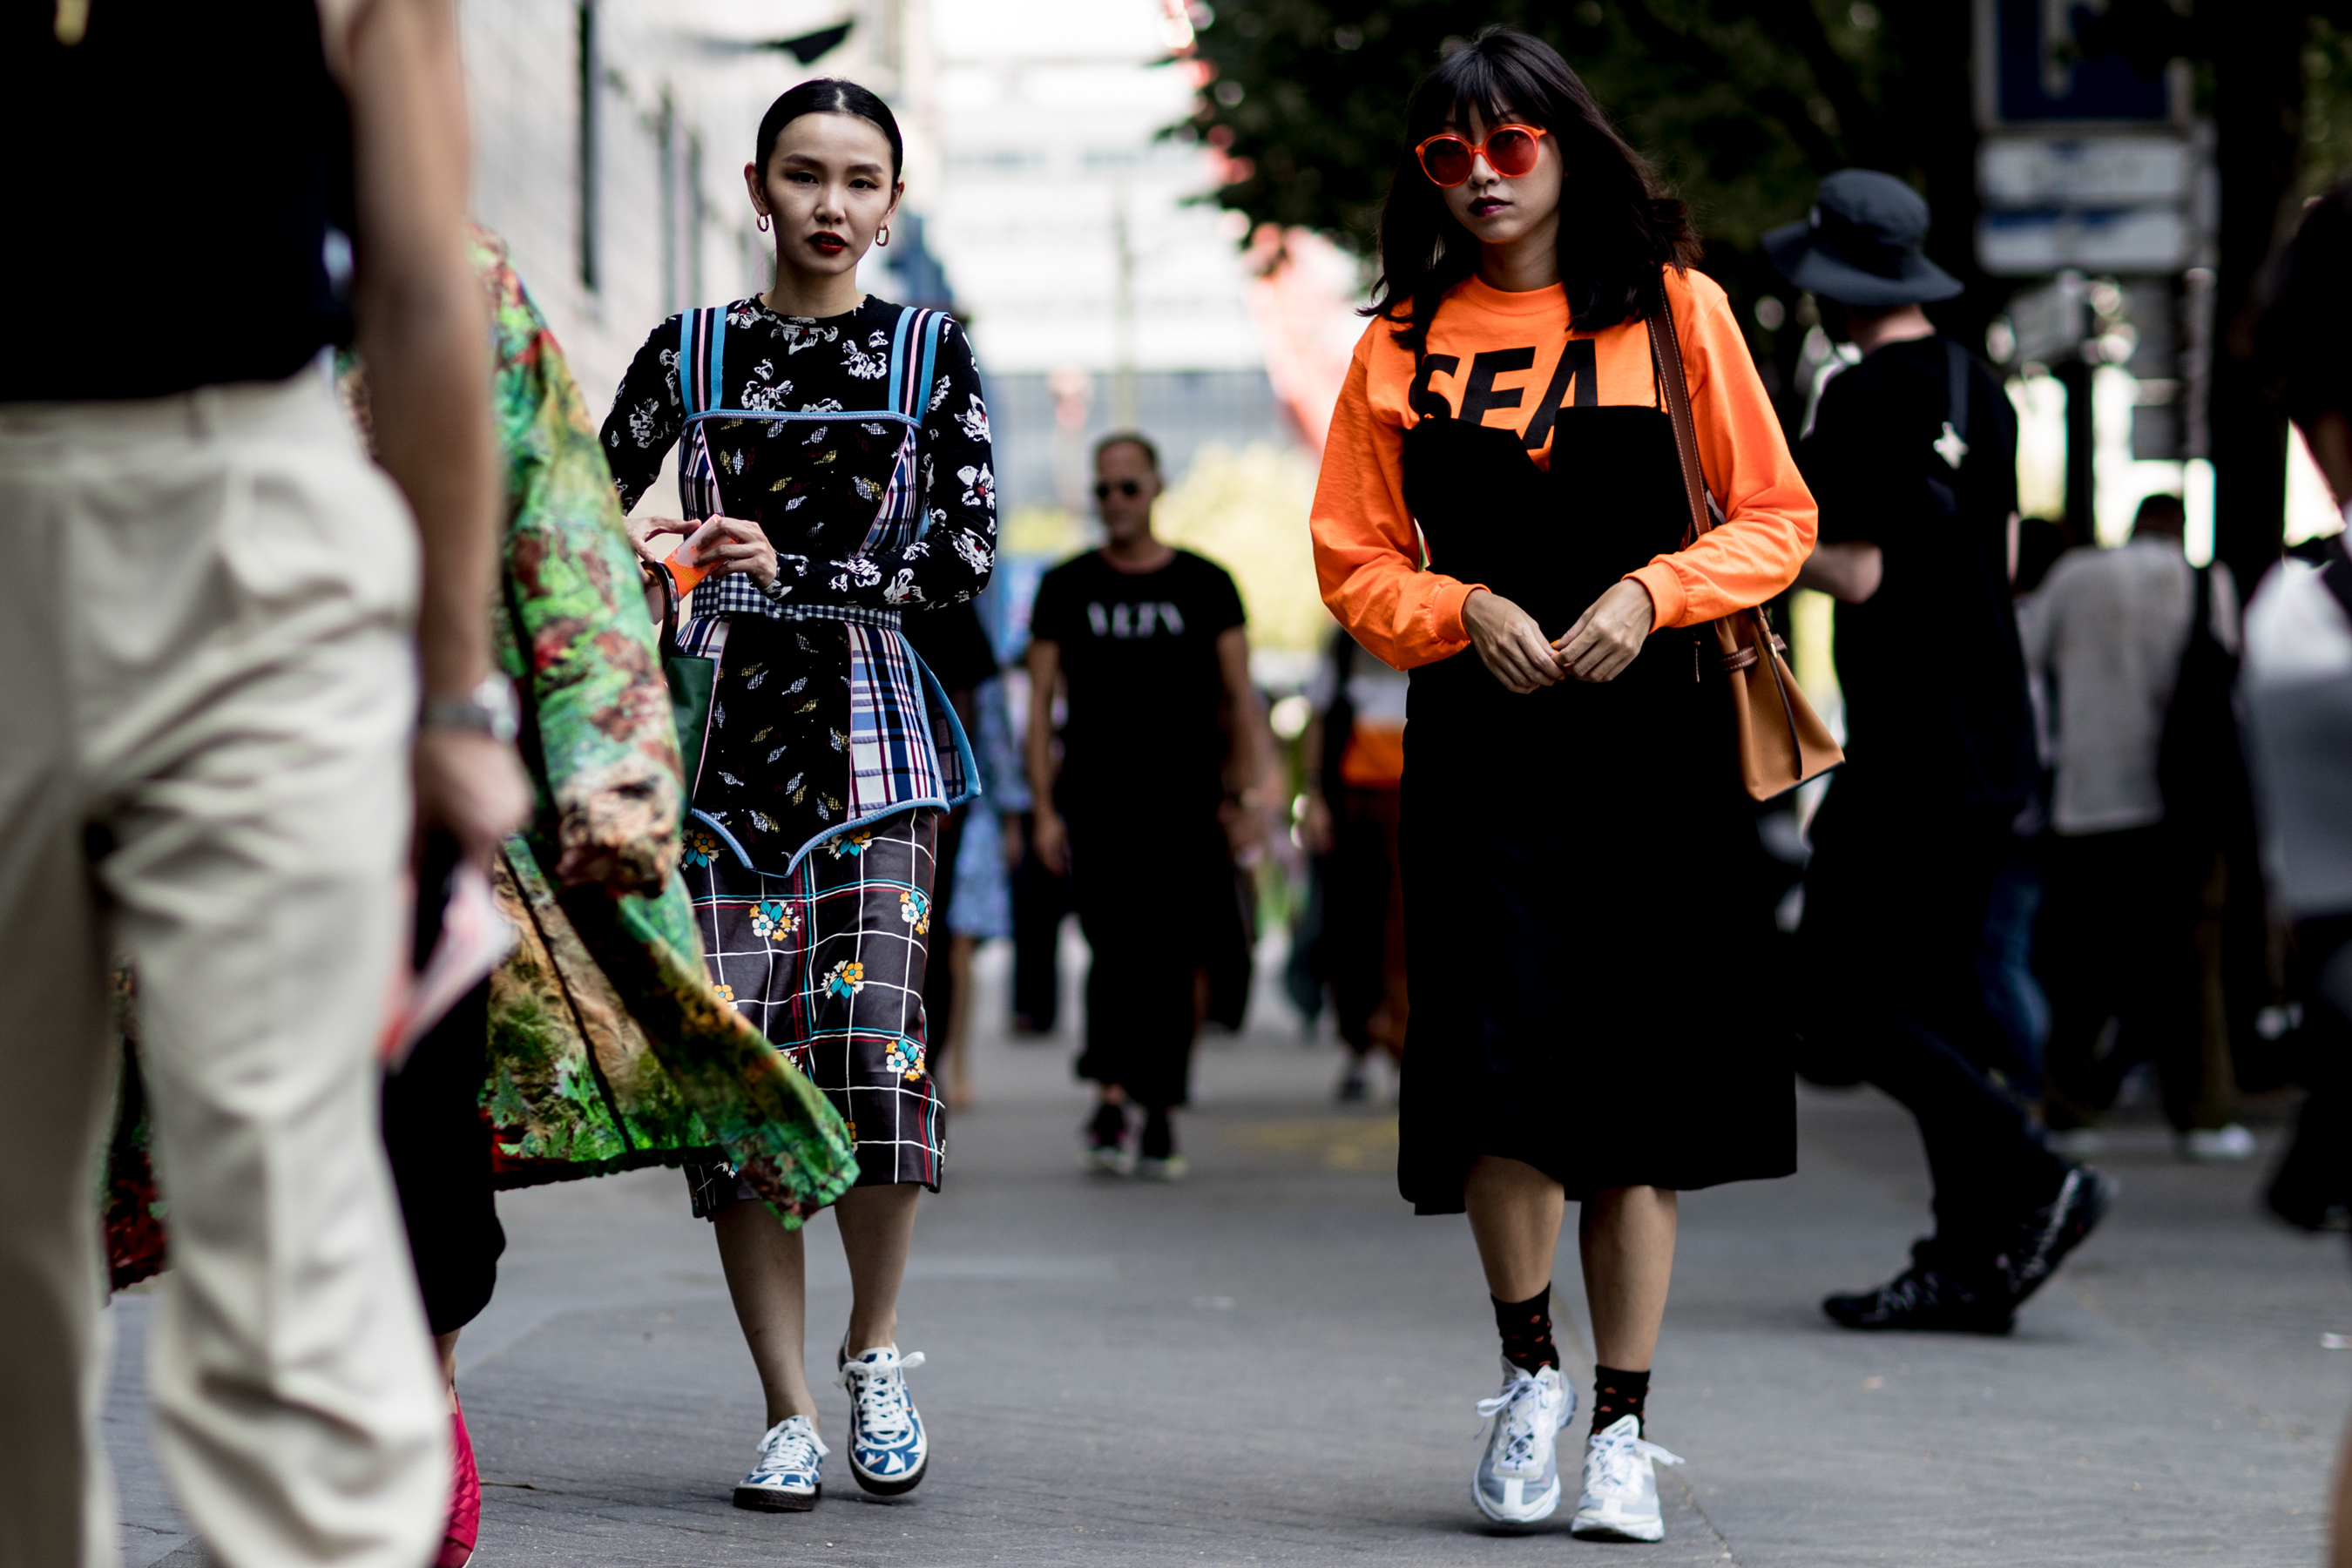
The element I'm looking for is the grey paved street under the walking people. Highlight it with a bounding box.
[111,950,2352,1568]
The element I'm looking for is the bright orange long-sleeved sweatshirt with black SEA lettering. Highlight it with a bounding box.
[1310,268,1814,670]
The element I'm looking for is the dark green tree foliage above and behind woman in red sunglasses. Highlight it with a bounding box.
[1183,0,2002,399]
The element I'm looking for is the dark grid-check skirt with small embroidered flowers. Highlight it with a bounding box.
[682,808,948,1218]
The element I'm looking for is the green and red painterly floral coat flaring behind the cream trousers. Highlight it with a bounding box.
[101,228,856,1288]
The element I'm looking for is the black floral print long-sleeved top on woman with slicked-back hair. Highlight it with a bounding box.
[602,299,997,870]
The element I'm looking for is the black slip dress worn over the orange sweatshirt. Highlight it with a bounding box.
[1397,324,1797,1213]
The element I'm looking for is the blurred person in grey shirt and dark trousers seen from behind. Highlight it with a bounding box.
[2020,496,2258,1159]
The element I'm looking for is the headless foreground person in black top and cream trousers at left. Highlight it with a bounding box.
[0,0,530,1568]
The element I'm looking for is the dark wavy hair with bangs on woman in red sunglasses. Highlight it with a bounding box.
[1364,26,1700,355]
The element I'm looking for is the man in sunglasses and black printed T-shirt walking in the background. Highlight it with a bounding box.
[1025,430,1266,1180]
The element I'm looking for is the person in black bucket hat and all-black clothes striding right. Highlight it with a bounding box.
[1764,169,2114,1333]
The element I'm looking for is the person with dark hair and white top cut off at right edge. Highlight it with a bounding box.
[2239,186,2352,1568]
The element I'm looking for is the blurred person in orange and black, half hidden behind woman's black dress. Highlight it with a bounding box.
[1303,630,1411,1103]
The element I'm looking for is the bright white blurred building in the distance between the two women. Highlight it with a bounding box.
[929,0,1289,515]
